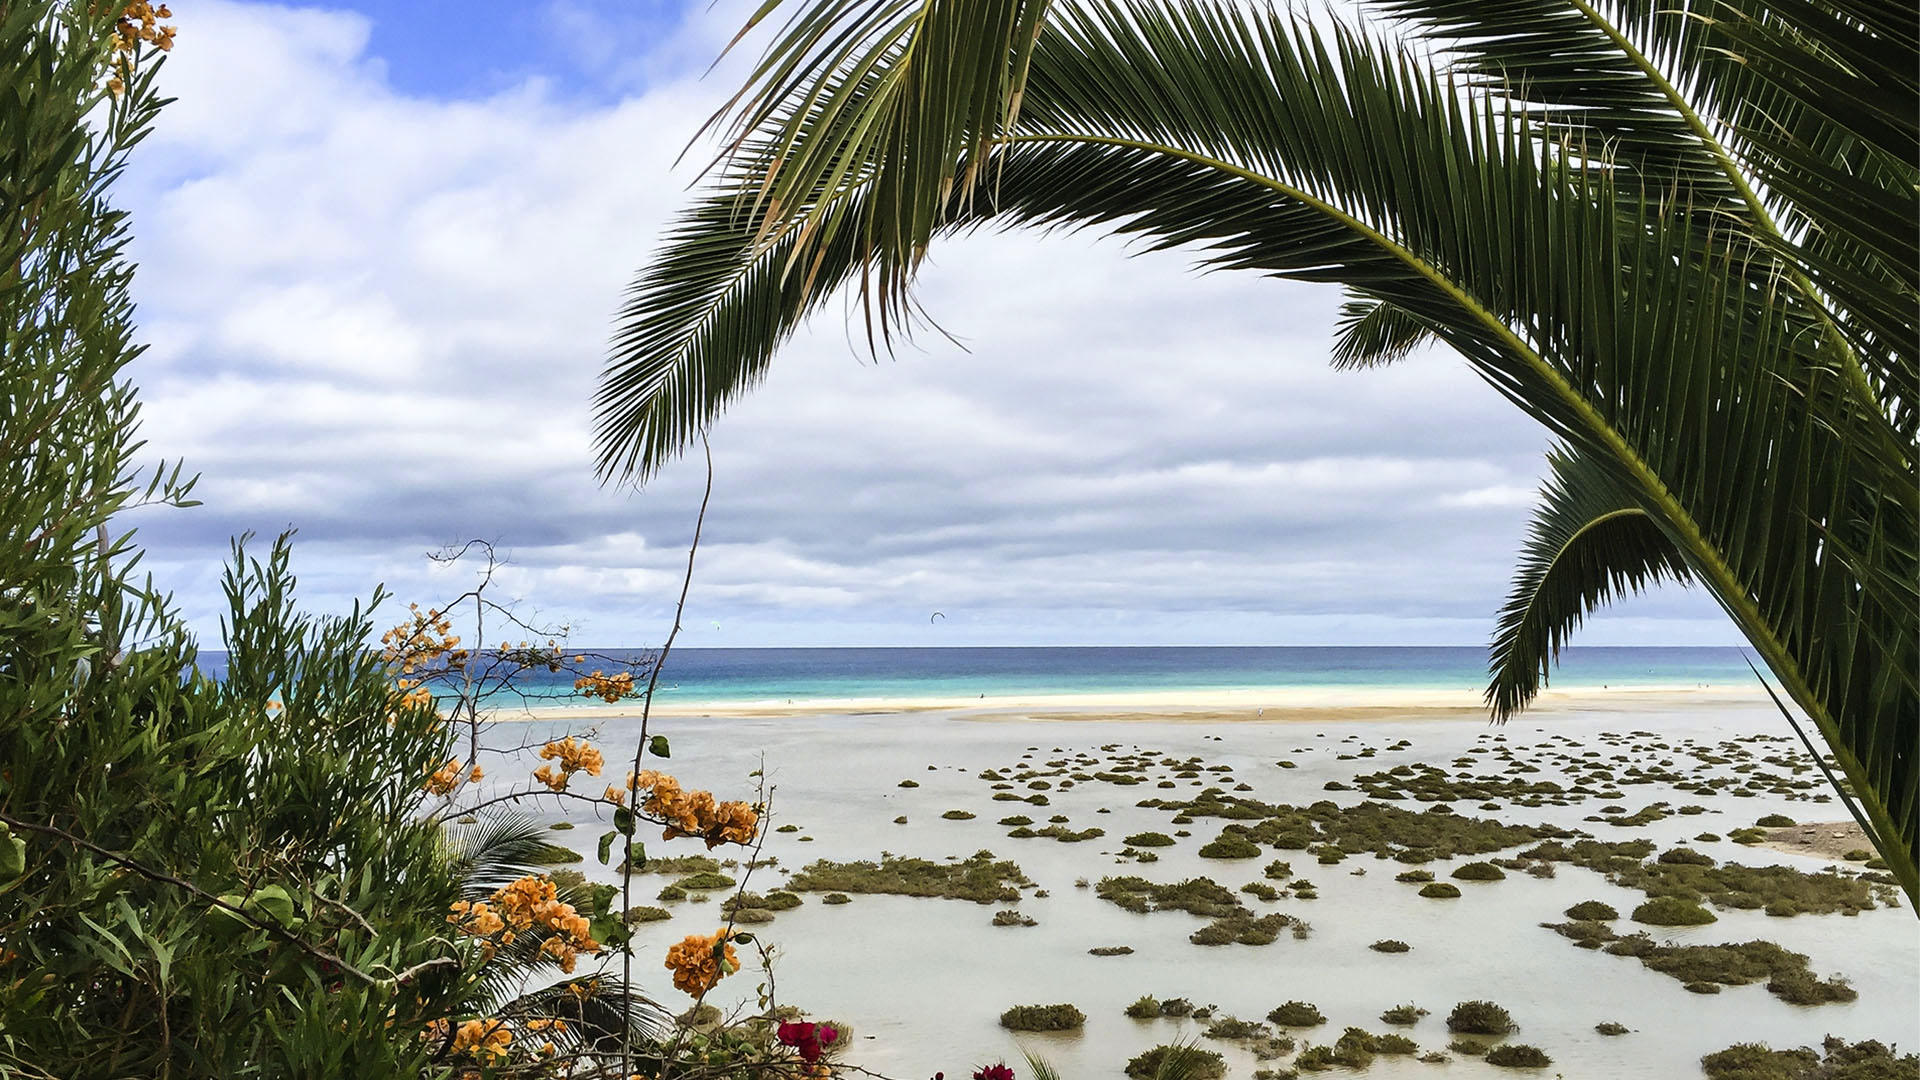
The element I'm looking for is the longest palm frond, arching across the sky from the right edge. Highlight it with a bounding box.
[603,0,1920,888]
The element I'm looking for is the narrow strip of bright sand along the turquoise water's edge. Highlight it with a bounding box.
[493,684,1768,723]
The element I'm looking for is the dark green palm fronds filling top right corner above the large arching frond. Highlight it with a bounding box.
[1373,0,1920,440]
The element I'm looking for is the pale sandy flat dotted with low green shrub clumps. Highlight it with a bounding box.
[478,686,1920,1080]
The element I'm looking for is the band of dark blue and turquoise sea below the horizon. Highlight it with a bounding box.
[314,646,1753,705]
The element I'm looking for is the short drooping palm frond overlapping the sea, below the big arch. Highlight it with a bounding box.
[1486,452,1692,721]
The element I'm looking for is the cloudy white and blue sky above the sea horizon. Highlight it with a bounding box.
[119,0,1740,648]
